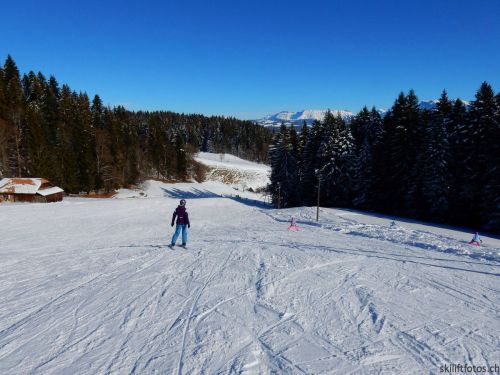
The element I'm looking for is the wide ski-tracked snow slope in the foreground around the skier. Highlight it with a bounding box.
[0,177,500,374]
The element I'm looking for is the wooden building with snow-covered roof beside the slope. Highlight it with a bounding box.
[0,178,64,203]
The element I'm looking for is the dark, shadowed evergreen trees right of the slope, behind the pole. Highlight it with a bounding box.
[269,82,500,233]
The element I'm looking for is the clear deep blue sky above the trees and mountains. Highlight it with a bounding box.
[0,0,500,118]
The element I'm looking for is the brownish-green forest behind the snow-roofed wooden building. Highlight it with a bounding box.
[0,56,271,193]
